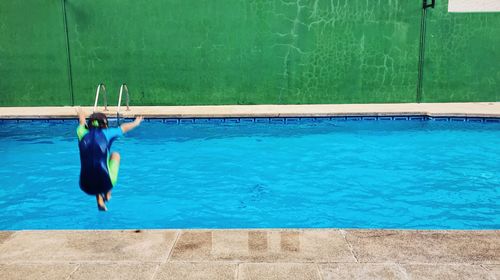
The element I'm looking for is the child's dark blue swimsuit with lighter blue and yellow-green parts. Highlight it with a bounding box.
[76,125,123,195]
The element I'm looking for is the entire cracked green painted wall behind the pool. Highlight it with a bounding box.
[0,0,500,106]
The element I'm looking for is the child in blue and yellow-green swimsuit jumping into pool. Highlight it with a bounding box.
[76,108,142,211]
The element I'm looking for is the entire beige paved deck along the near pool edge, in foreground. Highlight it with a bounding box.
[0,229,500,280]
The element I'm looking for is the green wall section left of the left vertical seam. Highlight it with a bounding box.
[0,0,71,106]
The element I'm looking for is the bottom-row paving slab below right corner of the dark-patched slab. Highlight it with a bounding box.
[319,263,408,280]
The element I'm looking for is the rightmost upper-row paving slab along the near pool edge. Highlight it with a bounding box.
[346,230,500,264]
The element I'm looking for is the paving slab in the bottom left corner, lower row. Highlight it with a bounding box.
[0,264,78,280]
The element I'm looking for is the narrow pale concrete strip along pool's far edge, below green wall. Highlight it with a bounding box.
[0,102,500,119]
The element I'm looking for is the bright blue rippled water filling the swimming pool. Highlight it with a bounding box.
[0,118,500,230]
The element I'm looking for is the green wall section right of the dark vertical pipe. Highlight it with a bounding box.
[422,0,500,102]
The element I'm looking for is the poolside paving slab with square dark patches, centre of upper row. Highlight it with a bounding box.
[171,230,356,262]
